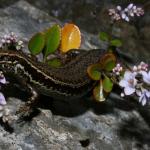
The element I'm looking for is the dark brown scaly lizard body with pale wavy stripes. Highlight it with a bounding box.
[0,49,105,99]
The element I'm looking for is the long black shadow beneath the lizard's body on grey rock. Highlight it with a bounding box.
[37,91,135,117]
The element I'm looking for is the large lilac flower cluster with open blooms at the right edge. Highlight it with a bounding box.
[119,62,150,105]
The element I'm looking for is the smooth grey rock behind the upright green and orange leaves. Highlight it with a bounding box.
[0,1,103,49]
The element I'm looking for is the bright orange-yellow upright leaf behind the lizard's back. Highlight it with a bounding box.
[60,23,81,53]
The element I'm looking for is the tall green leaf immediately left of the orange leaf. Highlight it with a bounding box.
[44,25,61,57]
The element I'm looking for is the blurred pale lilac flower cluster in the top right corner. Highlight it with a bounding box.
[109,3,144,22]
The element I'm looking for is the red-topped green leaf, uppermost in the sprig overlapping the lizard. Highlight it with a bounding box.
[100,52,116,71]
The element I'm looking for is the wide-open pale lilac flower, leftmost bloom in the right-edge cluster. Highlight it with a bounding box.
[119,71,137,95]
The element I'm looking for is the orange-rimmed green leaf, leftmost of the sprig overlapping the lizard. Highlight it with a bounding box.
[87,64,101,80]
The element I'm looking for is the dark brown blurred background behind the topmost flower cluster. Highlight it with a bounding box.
[27,0,150,62]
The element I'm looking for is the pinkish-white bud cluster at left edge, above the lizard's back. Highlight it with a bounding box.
[0,32,24,50]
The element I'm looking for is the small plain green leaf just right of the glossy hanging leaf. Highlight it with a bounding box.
[103,76,113,93]
